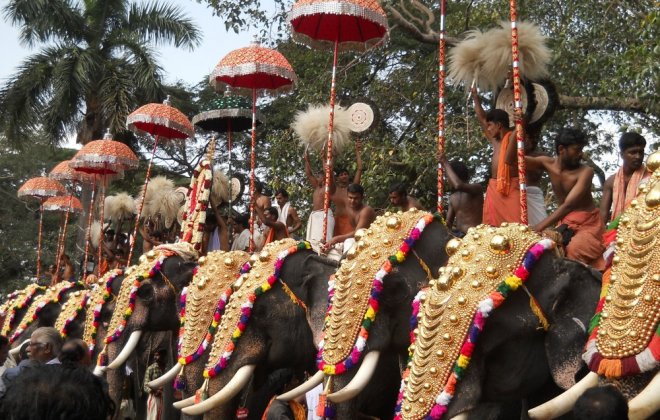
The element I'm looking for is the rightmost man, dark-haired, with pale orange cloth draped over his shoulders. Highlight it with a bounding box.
[600,133,651,222]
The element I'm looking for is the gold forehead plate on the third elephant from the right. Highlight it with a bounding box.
[323,211,427,365]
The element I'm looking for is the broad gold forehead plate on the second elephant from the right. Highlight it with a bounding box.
[401,224,540,420]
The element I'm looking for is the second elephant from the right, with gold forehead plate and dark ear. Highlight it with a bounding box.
[395,225,600,419]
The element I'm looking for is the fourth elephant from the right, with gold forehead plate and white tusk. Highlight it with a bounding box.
[177,239,338,418]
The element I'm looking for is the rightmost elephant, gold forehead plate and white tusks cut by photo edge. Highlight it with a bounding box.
[529,152,660,420]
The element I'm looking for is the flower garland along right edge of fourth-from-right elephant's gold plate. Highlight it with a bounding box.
[204,241,312,380]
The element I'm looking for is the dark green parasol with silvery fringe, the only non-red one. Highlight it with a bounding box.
[192,89,264,238]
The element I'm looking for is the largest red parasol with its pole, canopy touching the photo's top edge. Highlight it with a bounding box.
[288,0,389,238]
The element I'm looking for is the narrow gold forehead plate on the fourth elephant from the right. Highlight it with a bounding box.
[205,239,298,370]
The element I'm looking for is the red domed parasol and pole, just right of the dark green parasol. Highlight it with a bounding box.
[209,43,297,252]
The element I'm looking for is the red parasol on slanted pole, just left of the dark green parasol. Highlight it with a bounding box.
[126,95,195,265]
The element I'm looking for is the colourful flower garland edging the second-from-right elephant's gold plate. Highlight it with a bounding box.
[394,239,555,420]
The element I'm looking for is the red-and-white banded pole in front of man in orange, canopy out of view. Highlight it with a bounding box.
[509,0,529,225]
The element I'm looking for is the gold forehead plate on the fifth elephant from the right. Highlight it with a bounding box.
[179,251,249,357]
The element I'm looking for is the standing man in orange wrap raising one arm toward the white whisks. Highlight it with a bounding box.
[471,88,520,226]
